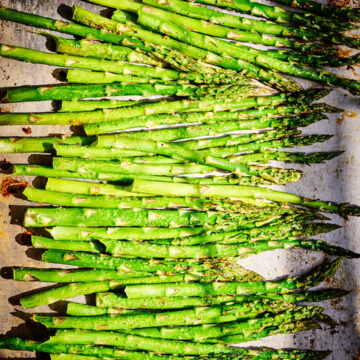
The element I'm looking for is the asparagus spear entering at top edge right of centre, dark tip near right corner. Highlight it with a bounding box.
[191,0,354,31]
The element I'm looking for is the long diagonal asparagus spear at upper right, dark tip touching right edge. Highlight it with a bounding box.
[138,12,360,94]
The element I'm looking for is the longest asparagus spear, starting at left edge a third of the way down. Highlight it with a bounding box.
[0,89,329,125]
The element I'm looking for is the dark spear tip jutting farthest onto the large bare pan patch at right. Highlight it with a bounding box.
[229,151,343,165]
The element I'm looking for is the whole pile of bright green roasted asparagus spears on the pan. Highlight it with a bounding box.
[0,0,360,360]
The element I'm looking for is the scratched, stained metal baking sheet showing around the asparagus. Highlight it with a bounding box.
[0,0,360,360]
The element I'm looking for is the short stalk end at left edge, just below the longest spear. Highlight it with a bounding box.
[0,136,93,152]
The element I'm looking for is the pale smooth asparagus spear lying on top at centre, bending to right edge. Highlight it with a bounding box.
[131,180,360,217]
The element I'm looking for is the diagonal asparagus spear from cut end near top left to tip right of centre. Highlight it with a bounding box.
[73,6,300,91]
